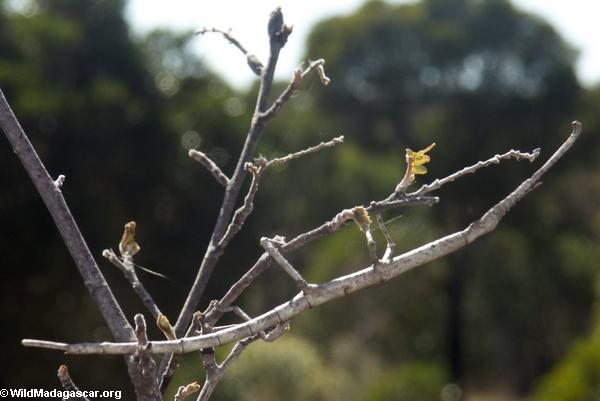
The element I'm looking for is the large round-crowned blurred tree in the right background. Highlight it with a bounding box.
[268,0,592,390]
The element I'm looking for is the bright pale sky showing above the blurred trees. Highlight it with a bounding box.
[127,0,600,88]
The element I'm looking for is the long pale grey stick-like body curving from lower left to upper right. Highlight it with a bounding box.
[23,122,581,354]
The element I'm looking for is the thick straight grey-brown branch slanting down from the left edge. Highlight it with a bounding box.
[0,90,134,341]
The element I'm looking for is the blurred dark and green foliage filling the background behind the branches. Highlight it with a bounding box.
[0,0,600,401]
